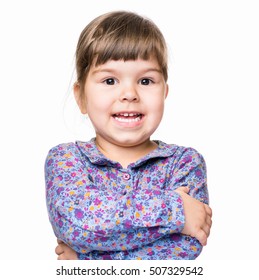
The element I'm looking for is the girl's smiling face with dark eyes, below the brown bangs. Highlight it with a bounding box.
[74,59,168,147]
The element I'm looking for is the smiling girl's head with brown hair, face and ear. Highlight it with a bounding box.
[74,12,168,151]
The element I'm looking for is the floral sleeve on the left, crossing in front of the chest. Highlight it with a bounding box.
[45,144,184,253]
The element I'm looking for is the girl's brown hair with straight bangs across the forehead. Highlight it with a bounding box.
[76,11,167,83]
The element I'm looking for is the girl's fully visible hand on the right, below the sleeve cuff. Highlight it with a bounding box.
[176,187,212,246]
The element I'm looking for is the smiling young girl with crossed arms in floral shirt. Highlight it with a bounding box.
[45,11,212,260]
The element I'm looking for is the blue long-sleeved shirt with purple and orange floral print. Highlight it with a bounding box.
[45,139,208,260]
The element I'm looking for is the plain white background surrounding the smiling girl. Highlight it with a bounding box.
[0,0,259,260]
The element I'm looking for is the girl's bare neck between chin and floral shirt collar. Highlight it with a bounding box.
[95,136,158,168]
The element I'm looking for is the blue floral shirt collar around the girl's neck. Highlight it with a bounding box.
[76,138,178,168]
